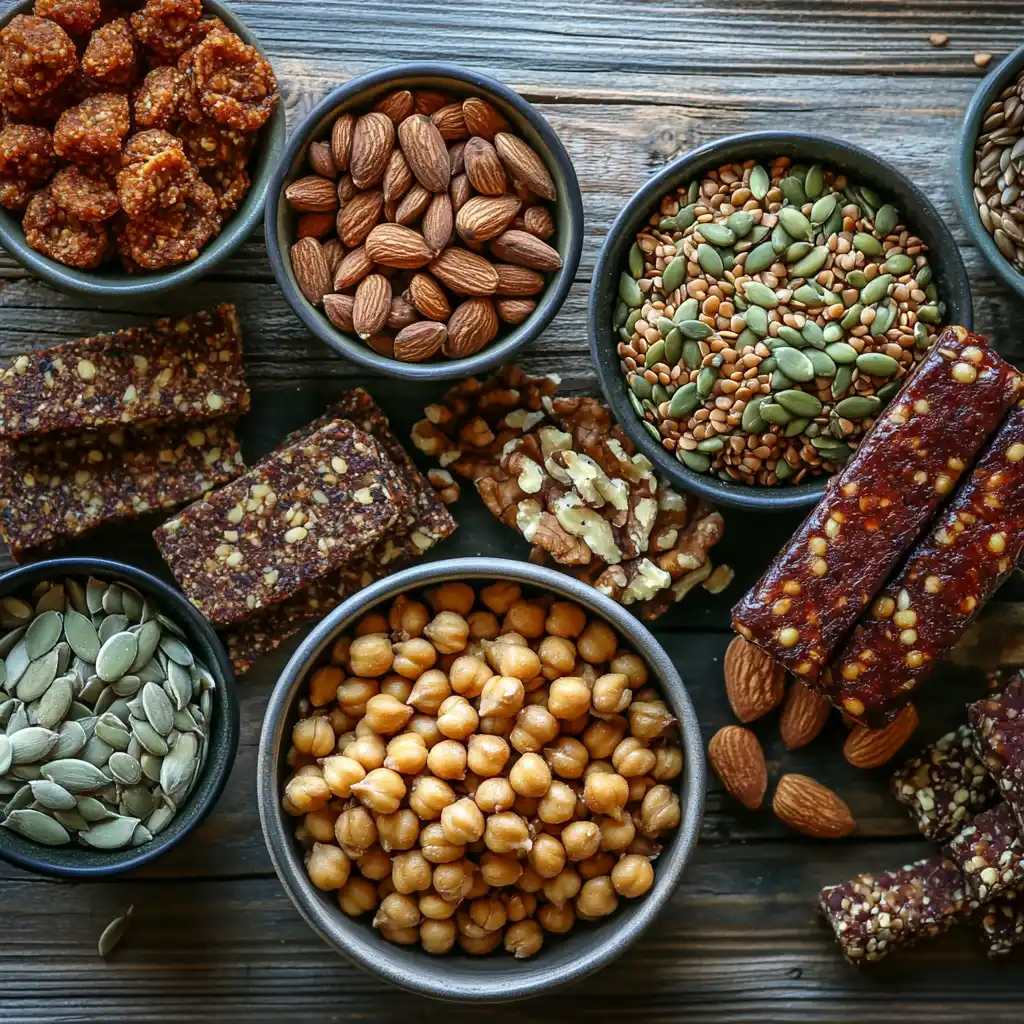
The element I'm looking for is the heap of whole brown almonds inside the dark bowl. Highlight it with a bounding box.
[285,89,562,362]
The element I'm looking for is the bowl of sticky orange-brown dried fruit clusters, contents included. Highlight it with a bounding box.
[0,0,285,296]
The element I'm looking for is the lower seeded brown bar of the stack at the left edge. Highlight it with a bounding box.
[0,420,245,559]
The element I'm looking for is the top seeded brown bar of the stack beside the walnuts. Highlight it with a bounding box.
[154,421,413,626]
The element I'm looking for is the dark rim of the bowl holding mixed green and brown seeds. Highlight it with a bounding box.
[587,131,974,512]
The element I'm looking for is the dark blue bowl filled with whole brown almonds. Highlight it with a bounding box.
[266,62,583,380]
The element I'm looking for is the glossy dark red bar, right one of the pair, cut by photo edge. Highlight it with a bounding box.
[831,406,1024,726]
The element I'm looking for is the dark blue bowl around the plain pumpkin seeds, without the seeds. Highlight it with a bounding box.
[0,558,239,879]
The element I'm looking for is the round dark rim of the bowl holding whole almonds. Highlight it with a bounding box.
[264,60,584,381]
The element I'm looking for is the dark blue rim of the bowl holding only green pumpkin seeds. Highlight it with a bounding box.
[0,557,240,879]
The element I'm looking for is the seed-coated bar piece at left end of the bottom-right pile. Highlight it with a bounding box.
[819,856,965,966]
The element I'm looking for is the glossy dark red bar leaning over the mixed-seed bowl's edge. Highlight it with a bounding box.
[732,328,1021,692]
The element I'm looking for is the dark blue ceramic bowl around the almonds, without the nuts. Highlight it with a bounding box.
[265,61,583,381]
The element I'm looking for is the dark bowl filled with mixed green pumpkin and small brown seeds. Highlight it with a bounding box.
[589,132,972,511]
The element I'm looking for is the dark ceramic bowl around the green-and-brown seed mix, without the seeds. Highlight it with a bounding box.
[588,131,972,512]
